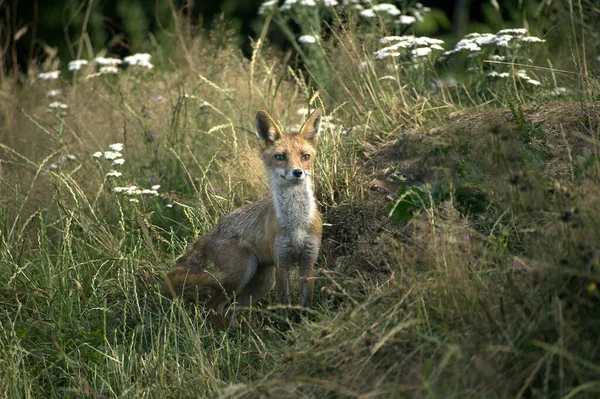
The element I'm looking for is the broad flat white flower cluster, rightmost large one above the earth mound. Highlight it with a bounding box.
[444,29,545,56]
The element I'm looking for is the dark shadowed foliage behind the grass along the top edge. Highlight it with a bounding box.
[0,0,548,72]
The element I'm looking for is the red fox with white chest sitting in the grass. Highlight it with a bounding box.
[160,108,323,327]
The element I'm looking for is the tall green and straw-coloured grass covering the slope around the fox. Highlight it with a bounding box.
[0,2,600,398]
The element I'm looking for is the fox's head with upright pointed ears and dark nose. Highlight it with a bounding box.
[255,108,321,184]
